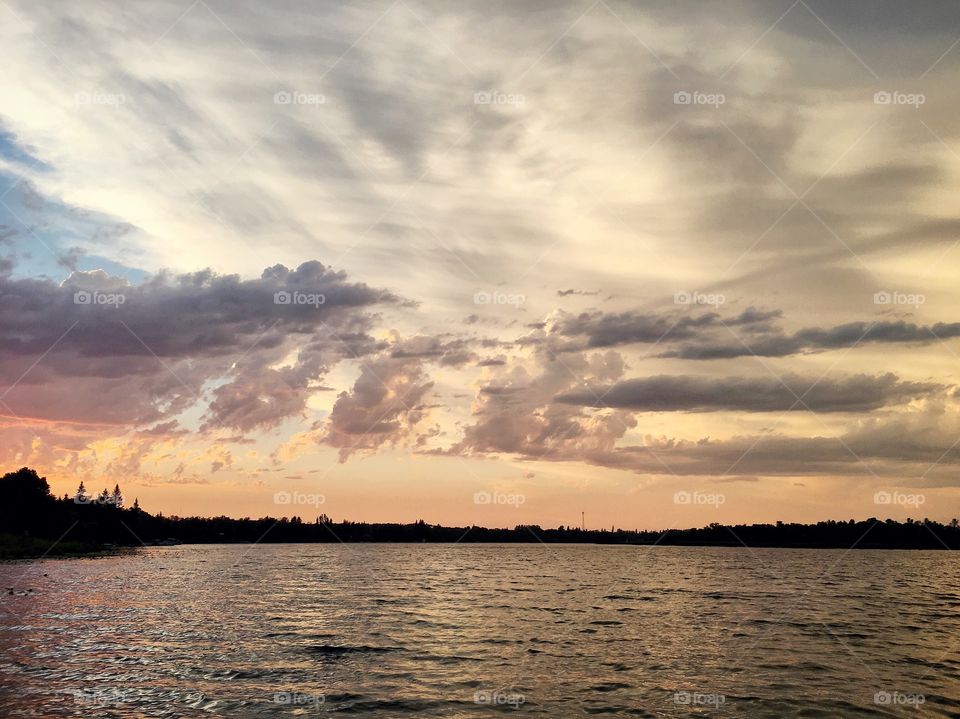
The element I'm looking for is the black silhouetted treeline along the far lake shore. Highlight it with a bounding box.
[0,467,960,557]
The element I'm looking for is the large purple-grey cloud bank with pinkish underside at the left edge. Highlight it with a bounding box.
[0,262,403,430]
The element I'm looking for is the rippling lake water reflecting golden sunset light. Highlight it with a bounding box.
[0,544,960,718]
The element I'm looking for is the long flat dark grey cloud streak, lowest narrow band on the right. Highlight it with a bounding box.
[555,374,944,412]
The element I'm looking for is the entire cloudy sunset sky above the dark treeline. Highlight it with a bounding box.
[0,0,960,529]
